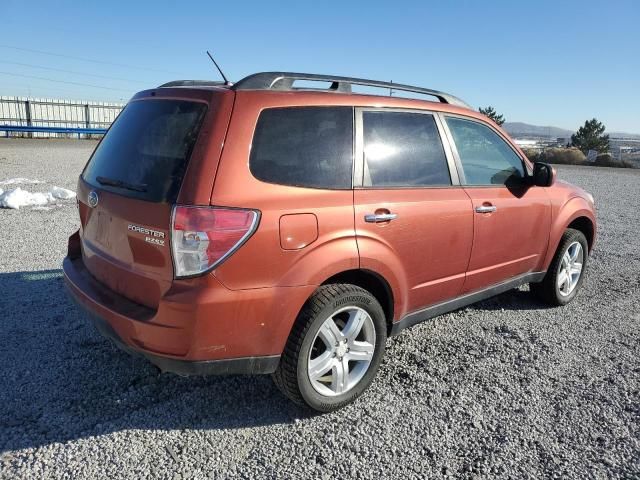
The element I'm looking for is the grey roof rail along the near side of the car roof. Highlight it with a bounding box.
[231,72,471,109]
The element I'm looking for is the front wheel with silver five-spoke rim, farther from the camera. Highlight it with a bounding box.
[529,228,589,306]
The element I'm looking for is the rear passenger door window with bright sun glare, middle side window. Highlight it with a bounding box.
[362,111,451,187]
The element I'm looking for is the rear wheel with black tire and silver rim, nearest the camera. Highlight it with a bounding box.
[272,284,387,412]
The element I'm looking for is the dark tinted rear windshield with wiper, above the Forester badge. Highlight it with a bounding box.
[82,99,207,203]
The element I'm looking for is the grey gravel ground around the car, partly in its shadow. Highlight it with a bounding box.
[0,140,640,479]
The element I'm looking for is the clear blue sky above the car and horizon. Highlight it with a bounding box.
[0,0,640,133]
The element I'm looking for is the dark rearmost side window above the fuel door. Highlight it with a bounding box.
[249,107,353,189]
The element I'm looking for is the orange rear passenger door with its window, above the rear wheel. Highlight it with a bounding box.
[354,108,473,315]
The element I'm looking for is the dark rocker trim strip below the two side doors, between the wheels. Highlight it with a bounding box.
[390,272,546,336]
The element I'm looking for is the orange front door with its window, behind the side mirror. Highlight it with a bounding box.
[445,115,551,292]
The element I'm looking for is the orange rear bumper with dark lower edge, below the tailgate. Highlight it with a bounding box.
[63,257,315,375]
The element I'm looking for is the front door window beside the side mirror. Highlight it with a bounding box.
[447,117,524,185]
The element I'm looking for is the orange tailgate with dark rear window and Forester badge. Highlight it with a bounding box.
[78,99,208,308]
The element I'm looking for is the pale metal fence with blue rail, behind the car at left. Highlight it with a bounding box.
[0,96,124,138]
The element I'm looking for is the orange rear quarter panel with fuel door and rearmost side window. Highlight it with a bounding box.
[205,104,358,288]
